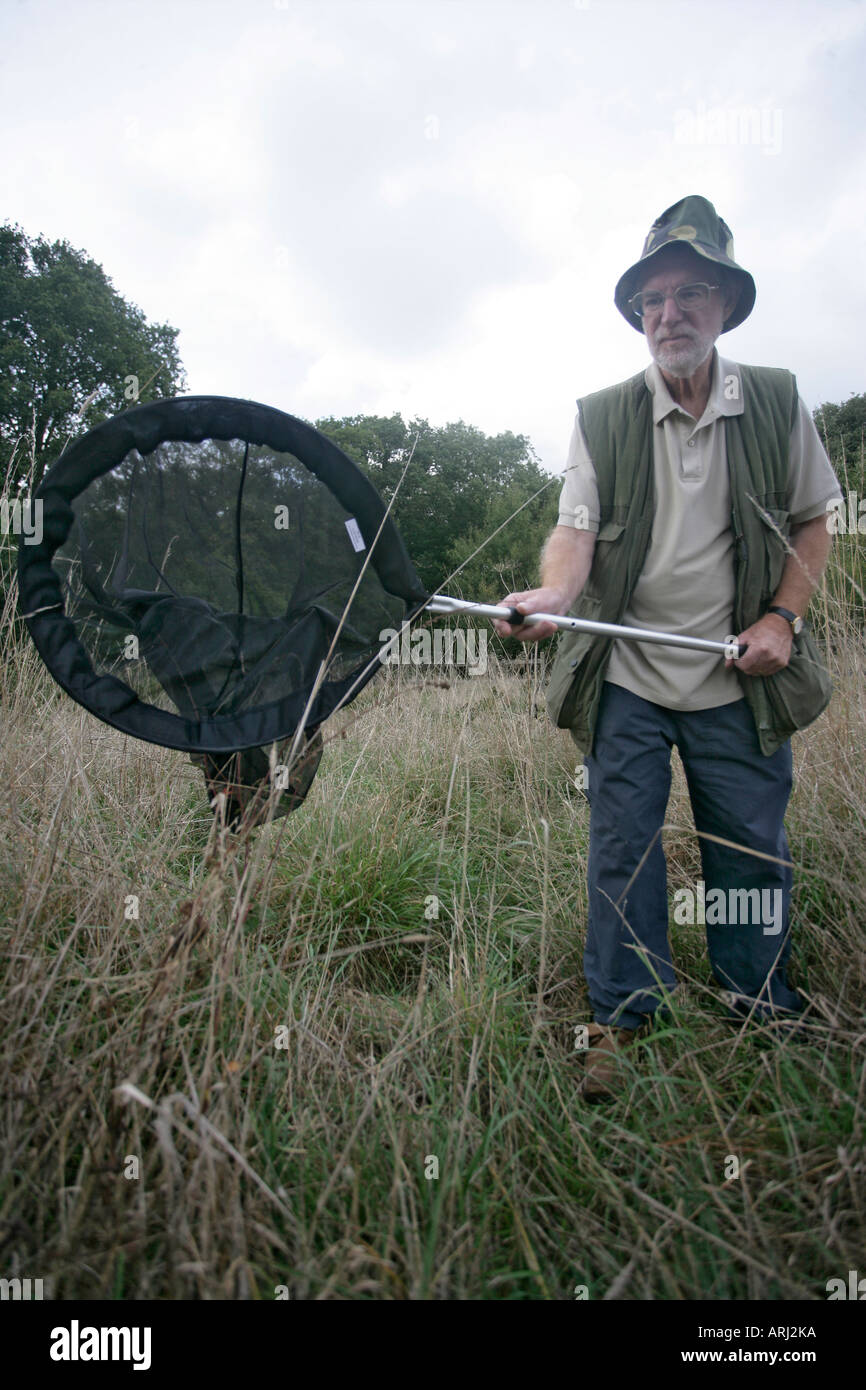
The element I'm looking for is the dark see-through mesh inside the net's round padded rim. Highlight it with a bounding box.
[53,439,406,717]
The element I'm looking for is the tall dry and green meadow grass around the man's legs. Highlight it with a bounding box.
[0,483,866,1301]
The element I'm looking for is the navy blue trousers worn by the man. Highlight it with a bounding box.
[584,681,805,1029]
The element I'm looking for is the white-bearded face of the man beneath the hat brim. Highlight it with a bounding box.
[638,246,735,377]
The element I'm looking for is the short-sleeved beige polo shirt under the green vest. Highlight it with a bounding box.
[559,349,842,710]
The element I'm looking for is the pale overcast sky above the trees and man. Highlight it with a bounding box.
[0,0,866,471]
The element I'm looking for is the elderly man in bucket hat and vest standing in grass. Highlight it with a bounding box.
[496,196,841,1101]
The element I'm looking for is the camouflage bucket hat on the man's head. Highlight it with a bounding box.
[613,193,755,334]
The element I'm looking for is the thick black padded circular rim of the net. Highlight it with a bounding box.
[18,396,430,753]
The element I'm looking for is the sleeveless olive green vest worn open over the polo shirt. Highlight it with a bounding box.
[546,364,833,756]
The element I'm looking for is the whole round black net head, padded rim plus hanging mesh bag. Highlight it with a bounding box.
[18,396,428,821]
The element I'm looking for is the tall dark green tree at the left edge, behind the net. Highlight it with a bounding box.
[0,222,186,491]
